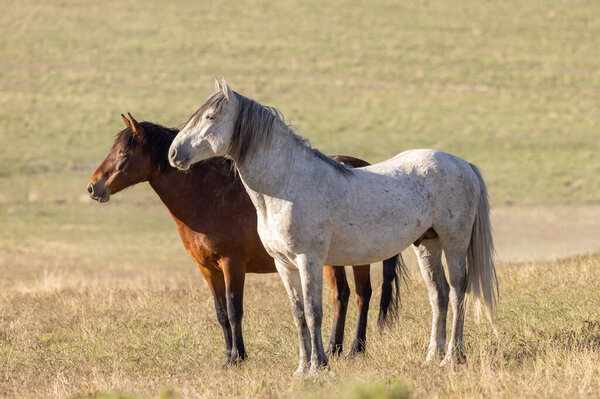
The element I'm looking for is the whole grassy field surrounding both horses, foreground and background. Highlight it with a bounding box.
[0,0,600,398]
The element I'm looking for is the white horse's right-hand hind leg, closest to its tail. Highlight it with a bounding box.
[440,248,467,366]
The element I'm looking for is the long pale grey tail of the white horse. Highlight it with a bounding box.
[466,164,498,330]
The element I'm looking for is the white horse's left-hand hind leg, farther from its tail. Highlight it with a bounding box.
[413,238,449,363]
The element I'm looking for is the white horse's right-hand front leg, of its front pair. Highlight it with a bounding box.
[296,254,327,373]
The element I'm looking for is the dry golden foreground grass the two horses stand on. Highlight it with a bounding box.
[0,252,600,398]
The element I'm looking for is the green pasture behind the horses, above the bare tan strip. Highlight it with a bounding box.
[0,0,600,204]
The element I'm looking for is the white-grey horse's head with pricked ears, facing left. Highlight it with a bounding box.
[169,79,238,170]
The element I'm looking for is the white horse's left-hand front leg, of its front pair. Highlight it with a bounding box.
[275,260,311,375]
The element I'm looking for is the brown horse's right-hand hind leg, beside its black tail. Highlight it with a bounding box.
[350,265,373,356]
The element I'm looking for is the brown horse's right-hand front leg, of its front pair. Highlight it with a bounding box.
[223,259,247,364]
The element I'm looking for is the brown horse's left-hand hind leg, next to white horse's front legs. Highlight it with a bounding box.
[323,266,350,355]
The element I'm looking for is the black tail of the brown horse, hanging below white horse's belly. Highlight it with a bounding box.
[377,254,408,330]
